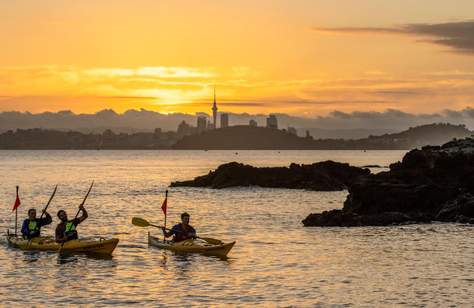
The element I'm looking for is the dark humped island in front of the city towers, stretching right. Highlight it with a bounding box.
[173,124,473,150]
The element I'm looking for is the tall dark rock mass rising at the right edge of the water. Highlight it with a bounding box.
[302,138,474,227]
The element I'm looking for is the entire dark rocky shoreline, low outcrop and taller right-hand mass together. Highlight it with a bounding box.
[170,138,474,227]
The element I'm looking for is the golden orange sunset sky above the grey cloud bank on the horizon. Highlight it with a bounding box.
[0,0,474,117]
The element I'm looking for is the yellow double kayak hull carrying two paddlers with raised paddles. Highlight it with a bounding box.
[7,235,119,255]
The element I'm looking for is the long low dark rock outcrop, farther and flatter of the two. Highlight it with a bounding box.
[170,161,370,191]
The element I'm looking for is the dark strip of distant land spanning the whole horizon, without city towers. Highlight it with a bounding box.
[0,123,473,150]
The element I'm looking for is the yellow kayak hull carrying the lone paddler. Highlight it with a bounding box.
[148,233,235,258]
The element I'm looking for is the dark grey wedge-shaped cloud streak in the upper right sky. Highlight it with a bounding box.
[312,20,474,54]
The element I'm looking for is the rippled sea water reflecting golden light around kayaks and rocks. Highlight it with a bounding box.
[0,151,474,306]
